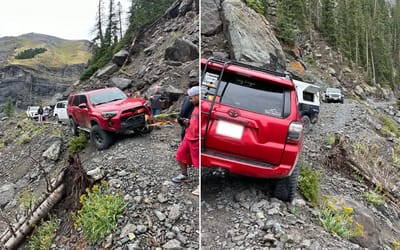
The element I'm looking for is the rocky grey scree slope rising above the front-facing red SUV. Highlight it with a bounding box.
[70,0,199,112]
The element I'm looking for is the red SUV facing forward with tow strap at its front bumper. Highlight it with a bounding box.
[67,88,152,150]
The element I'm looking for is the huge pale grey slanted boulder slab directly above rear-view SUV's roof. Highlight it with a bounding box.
[222,0,286,71]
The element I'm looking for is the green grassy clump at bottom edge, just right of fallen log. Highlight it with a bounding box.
[27,216,60,250]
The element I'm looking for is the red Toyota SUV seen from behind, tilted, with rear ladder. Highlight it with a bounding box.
[201,58,303,201]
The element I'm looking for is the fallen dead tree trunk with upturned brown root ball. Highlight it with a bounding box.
[0,156,90,250]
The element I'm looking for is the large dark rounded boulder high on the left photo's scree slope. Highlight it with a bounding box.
[165,39,199,62]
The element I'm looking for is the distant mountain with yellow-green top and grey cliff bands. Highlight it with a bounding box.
[0,33,90,110]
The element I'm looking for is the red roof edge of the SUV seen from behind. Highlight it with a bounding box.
[201,58,294,89]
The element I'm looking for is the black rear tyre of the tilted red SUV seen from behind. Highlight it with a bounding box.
[274,163,300,202]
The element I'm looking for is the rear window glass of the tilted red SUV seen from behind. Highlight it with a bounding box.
[201,72,290,117]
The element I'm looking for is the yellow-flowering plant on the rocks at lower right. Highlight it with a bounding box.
[318,196,363,239]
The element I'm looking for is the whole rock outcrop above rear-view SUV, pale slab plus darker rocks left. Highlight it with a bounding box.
[201,0,286,71]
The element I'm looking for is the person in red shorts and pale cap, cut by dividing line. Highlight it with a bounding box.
[172,86,200,195]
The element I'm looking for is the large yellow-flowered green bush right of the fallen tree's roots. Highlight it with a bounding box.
[72,181,126,243]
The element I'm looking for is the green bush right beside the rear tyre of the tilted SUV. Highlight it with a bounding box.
[298,161,320,206]
